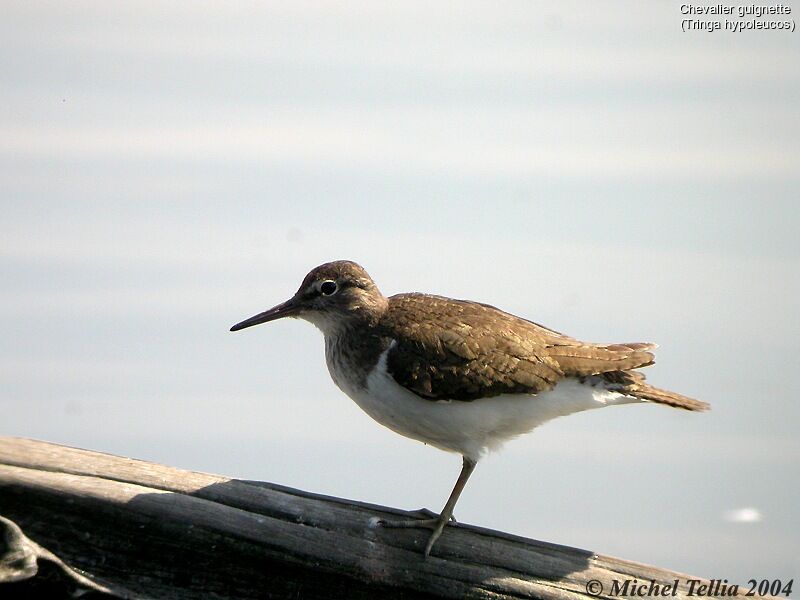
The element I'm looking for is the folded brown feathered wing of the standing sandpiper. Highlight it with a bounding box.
[384,294,654,400]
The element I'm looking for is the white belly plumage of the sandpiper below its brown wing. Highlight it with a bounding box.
[328,342,641,460]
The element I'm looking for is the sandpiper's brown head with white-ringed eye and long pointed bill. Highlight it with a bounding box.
[231,260,387,335]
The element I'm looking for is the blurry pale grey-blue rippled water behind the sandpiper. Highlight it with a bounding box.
[0,1,800,582]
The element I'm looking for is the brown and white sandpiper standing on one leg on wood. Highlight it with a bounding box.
[231,260,709,557]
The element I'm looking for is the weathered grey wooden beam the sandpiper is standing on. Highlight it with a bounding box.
[0,437,712,600]
